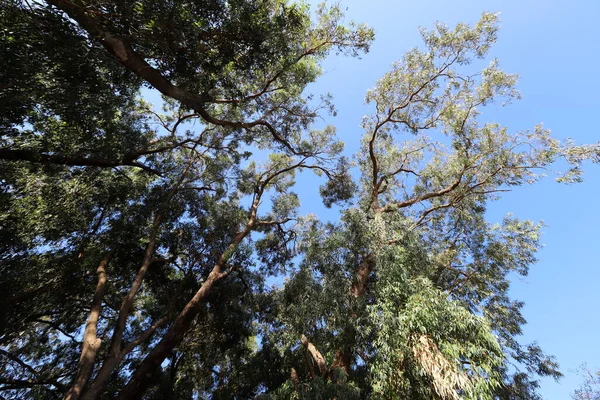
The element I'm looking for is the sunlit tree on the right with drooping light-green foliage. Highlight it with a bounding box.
[264,14,598,399]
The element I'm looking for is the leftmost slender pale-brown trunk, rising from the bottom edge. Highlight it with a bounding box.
[65,252,112,400]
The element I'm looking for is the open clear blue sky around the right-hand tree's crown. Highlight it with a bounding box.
[301,0,600,400]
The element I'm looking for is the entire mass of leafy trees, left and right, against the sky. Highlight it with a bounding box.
[0,0,600,400]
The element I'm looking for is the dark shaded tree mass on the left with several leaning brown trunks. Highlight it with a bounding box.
[0,1,372,399]
